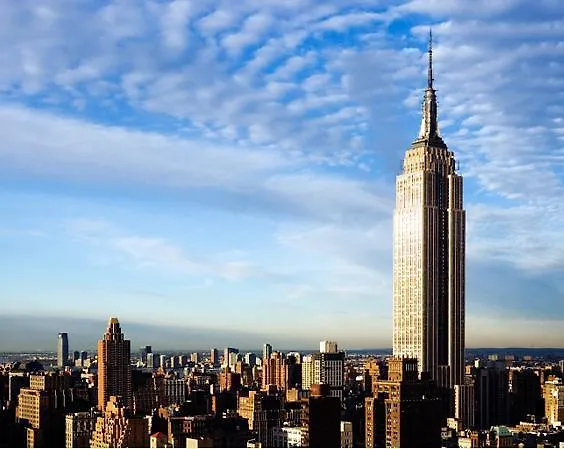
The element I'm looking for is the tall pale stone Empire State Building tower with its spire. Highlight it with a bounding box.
[393,33,466,388]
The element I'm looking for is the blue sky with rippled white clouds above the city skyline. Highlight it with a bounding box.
[0,0,564,349]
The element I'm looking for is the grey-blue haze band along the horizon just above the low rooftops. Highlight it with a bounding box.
[0,315,564,352]
